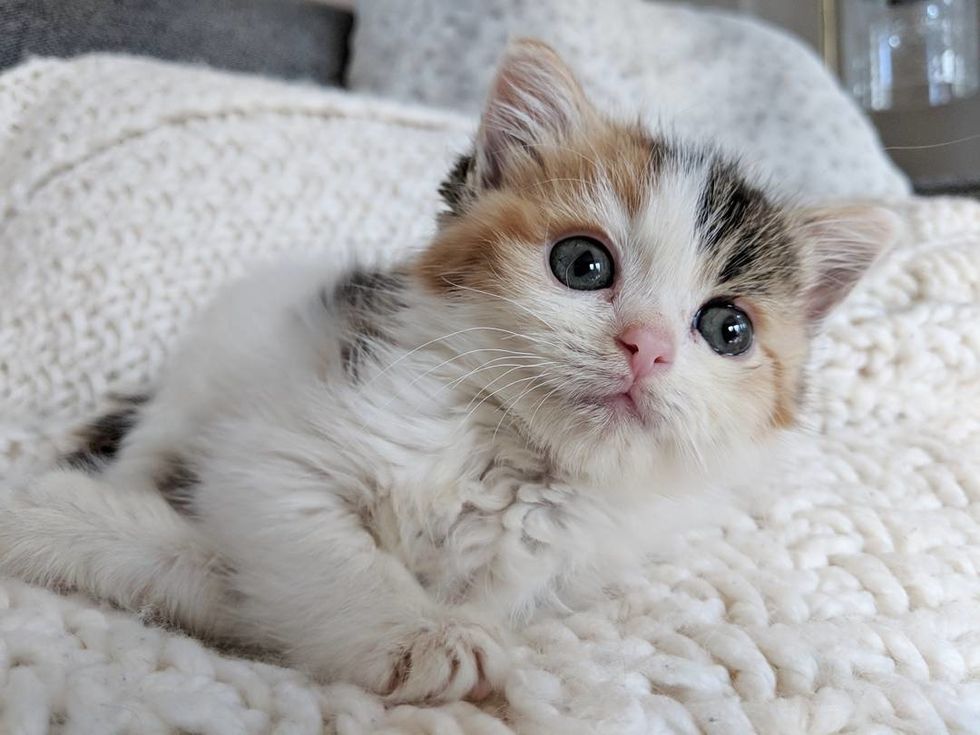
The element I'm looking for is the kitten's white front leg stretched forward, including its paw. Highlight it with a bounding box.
[211,486,506,702]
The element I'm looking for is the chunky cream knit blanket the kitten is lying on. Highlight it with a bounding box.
[0,56,980,735]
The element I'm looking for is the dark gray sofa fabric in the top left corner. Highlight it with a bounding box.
[0,0,351,84]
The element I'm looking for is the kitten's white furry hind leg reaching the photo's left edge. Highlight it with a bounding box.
[0,470,233,636]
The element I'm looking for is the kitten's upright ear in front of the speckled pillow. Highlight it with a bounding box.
[475,39,595,188]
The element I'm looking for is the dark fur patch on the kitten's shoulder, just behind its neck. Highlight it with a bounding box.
[325,271,406,382]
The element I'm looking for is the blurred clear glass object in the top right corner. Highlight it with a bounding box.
[837,0,980,110]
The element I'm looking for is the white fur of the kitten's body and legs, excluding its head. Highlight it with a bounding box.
[0,256,744,700]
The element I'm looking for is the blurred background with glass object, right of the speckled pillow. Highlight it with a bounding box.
[694,0,980,196]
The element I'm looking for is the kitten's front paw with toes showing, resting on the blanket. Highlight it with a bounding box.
[385,622,507,703]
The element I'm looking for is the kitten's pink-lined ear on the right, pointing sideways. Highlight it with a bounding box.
[801,205,901,322]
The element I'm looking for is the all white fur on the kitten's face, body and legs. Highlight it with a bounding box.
[0,41,856,701]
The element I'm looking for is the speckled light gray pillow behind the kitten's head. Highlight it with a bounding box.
[348,0,909,201]
